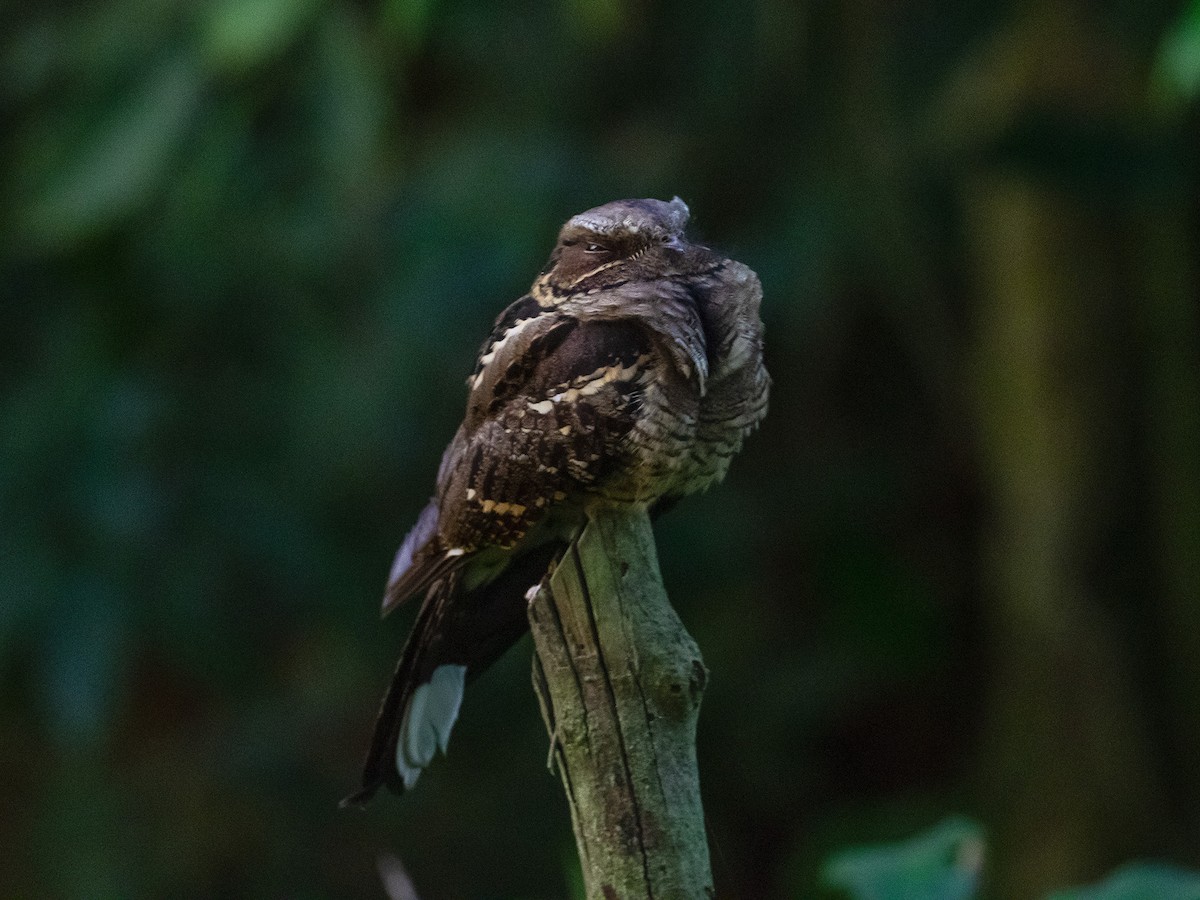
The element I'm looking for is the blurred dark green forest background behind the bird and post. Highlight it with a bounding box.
[0,0,1200,900]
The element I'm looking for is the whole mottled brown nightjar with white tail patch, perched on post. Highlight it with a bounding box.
[344,197,770,804]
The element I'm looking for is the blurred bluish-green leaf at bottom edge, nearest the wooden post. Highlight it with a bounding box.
[822,817,984,900]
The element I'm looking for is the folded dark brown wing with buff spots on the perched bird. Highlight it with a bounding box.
[384,301,658,612]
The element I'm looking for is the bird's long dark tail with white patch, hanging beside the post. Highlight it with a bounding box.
[342,545,560,806]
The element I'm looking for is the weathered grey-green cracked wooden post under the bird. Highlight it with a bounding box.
[529,510,713,900]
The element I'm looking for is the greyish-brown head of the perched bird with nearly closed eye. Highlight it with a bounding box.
[538,197,713,296]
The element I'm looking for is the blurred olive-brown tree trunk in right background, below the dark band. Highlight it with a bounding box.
[965,173,1163,896]
